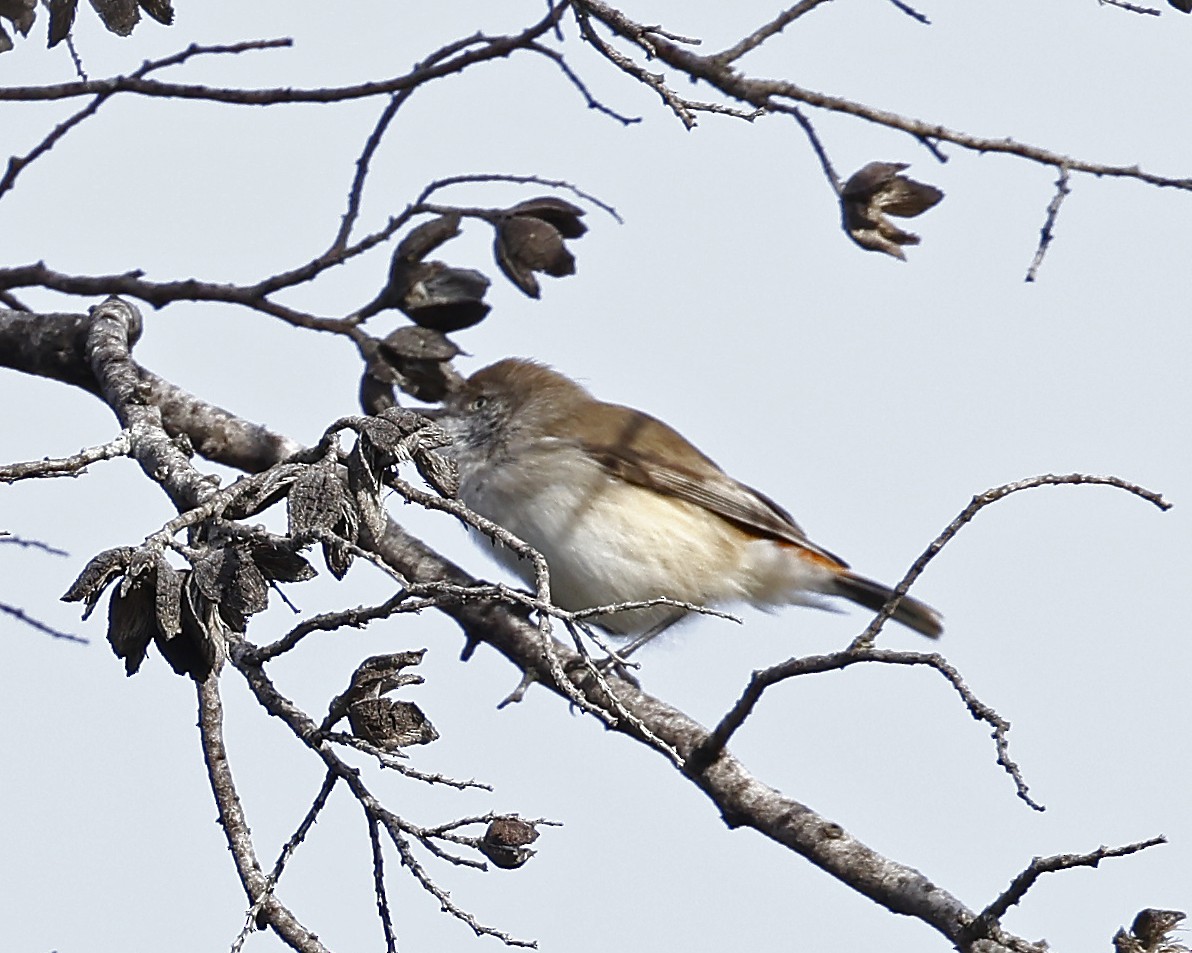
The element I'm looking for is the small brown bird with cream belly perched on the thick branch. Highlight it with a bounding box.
[439,358,942,637]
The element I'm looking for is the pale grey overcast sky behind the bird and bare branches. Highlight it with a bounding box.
[0,0,1192,953]
